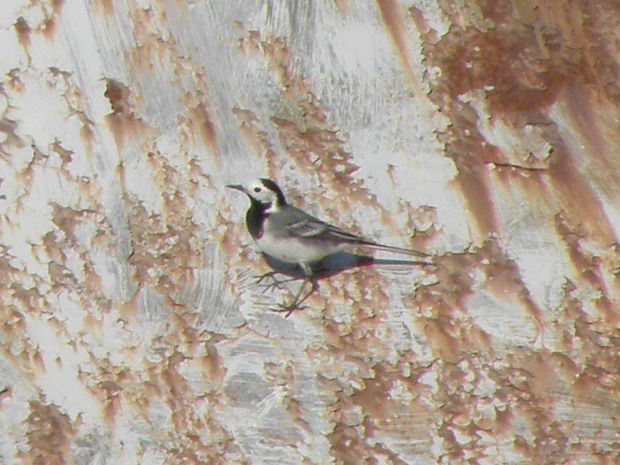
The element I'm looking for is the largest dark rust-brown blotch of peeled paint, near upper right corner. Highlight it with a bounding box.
[426,1,583,113]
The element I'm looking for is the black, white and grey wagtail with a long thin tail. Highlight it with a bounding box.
[226,178,428,314]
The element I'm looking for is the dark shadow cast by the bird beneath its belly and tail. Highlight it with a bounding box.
[262,252,433,280]
